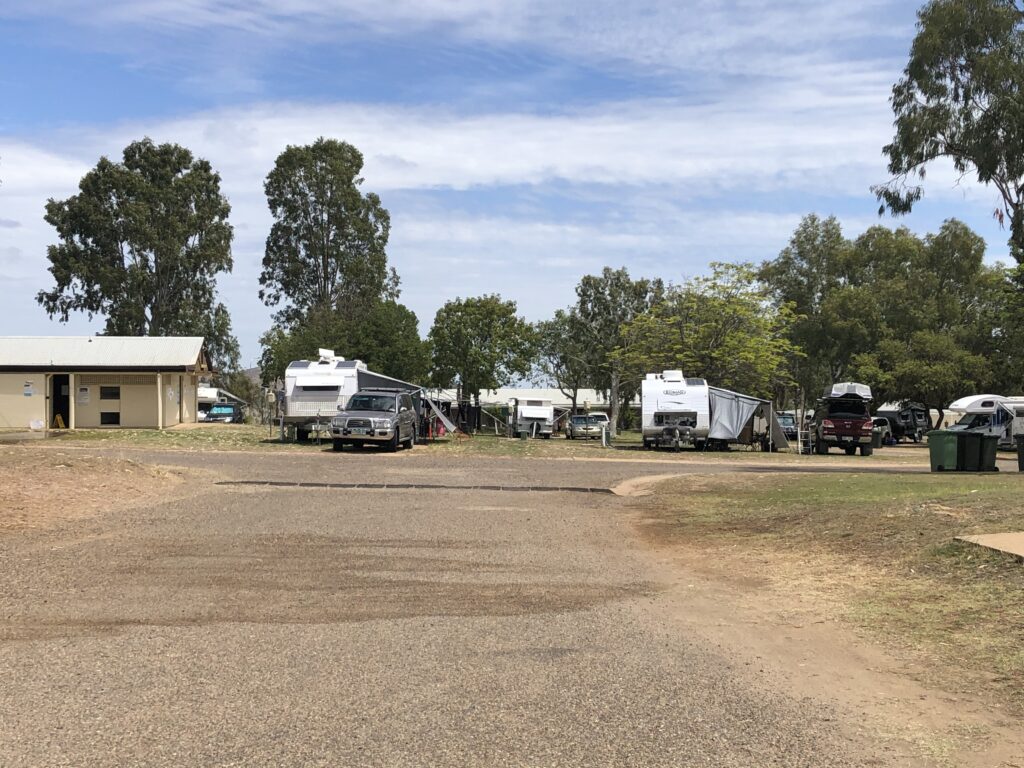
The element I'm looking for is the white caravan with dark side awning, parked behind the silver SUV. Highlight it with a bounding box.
[284,349,421,440]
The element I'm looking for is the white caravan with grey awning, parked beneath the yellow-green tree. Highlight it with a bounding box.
[640,371,790,450]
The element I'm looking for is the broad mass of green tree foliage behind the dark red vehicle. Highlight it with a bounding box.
[760,216,1007,410]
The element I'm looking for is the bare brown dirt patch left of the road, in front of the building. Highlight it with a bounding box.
[0,443,192,531]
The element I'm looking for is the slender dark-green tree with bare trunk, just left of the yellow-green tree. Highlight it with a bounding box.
[574,267,665,436]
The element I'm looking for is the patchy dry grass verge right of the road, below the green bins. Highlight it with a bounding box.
[643,473,1024,712]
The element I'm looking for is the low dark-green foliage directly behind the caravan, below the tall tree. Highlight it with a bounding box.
[260,300,430,384]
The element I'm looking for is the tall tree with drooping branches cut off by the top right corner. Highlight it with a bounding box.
[872,0,1024,263]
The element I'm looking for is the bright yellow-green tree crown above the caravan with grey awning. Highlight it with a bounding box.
[617,263,798,397]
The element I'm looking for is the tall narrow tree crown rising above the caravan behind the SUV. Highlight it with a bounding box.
[259,137,398,325]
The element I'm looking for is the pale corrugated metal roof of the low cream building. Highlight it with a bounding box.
[0,336,203,370]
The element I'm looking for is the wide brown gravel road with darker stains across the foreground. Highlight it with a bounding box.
[0,450,886,768]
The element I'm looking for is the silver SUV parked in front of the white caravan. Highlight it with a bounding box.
[331,389,417,452]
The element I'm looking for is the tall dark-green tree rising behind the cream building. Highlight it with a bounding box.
[36,138,239,368]
